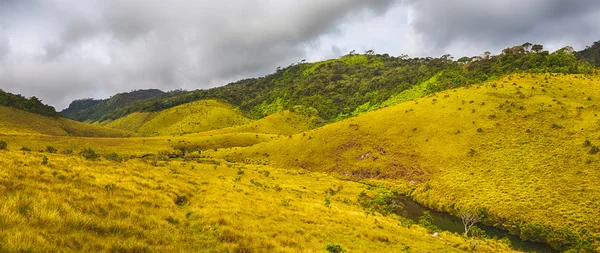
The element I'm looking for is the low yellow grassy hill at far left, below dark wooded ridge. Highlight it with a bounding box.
[0,106,131,137]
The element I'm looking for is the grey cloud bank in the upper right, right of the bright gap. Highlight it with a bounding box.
[404,0,600,54]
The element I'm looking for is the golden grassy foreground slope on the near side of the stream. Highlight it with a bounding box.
[0,151,510,252]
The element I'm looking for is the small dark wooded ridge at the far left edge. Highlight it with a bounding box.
[0,89,58,117]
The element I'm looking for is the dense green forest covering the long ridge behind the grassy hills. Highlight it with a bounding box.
[63,43,597,121]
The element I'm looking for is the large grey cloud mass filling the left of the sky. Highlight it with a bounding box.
[0,0,394,108]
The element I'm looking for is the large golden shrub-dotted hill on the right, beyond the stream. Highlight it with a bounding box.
[211,74,600,252]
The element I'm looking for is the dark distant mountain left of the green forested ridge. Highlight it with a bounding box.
[60,89,176,121]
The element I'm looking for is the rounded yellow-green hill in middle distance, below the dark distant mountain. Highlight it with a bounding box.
[100,100,250,135]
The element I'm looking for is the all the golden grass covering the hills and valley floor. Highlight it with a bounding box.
[0,74,600,252]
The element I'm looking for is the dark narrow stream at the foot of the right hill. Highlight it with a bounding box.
[398,196,558,253]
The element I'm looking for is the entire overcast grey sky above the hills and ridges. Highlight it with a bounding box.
[0,0,600,110]
